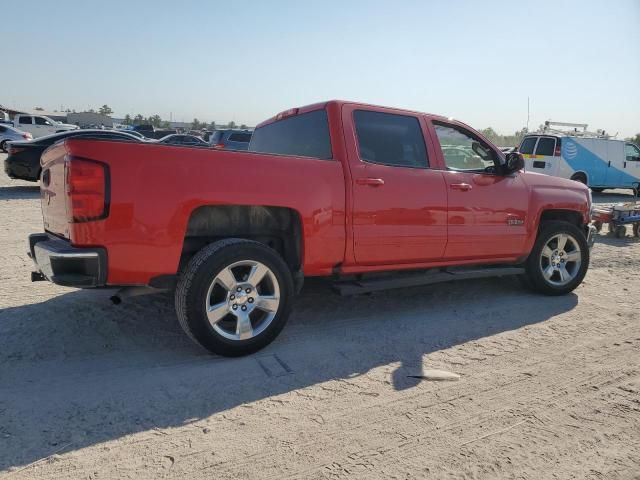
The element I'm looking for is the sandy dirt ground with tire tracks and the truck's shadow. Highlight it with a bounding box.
[0,155,640,480]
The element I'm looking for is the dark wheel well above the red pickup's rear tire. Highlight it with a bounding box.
[180,205,302,272]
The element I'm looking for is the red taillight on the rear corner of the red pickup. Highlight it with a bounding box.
[65,157,109,222]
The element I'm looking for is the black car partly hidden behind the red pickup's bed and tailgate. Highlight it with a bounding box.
[4,130,143,182]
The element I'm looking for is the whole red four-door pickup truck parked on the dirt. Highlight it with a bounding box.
[30,101,593,356]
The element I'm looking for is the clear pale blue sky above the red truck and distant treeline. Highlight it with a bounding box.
[5,0,640,136]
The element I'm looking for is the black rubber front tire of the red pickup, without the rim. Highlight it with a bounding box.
[525,220,589,295]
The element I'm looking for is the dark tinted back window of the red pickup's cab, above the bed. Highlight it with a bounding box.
[249,110,331,159]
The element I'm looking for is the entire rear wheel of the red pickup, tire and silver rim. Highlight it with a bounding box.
[175,238,294,357]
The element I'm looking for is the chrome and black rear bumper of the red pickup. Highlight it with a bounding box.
[29,233,107,288]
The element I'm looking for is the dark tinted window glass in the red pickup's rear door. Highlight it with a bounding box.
[353,110,428,168]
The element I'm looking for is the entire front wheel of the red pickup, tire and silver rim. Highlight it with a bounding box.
[526,221,589,295]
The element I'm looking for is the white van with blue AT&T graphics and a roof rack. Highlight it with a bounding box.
[519,122,640,195]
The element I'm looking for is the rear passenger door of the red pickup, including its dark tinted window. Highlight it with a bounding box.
[343,105,447,265]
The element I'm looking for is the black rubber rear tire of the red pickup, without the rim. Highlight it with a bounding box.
[175,238,294,357]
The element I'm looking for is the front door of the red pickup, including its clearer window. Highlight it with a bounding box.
[433,122,528,260]
